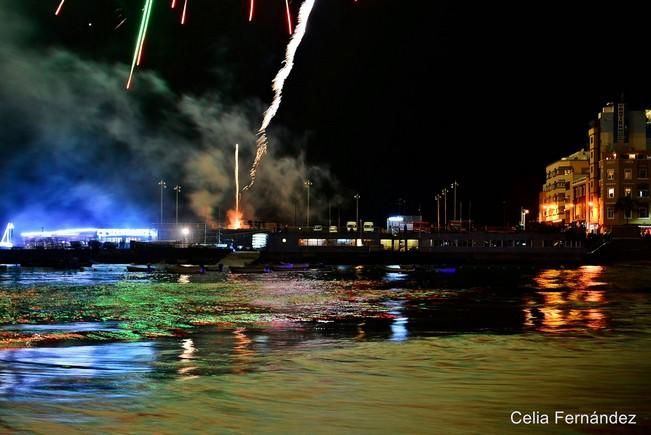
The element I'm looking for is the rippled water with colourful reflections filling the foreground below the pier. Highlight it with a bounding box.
[0,265,651,433]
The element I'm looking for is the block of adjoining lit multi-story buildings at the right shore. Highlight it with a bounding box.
[539,102,651,232]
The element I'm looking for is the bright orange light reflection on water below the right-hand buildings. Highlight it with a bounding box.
[524,266,609,333]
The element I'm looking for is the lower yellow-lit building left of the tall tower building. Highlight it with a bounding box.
[538,149,589,224]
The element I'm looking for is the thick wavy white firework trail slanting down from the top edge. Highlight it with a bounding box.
[242,0,316,191]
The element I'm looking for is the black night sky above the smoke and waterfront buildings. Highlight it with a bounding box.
[0,0,651,230]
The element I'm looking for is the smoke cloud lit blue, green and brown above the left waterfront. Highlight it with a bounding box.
[0,3,337,235]
